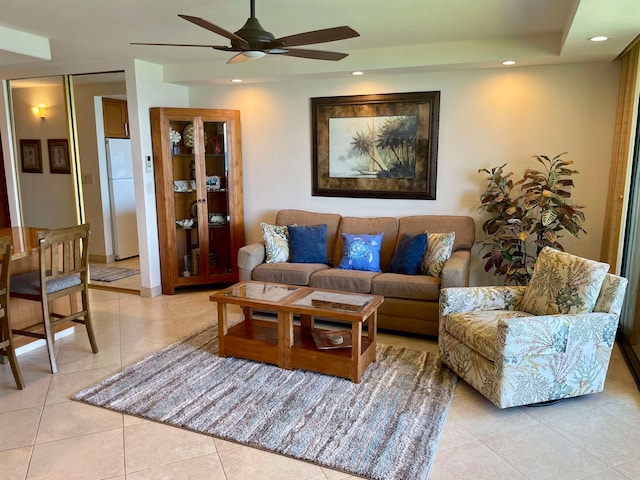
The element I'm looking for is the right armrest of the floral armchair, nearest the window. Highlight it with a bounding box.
[496,312,618,361]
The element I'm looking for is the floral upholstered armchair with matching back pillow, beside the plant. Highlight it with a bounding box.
[438,247,627,408]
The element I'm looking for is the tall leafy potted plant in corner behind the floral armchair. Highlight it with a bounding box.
[478,152,587,285]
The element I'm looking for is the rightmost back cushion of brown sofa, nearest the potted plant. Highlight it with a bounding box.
[398,215,476,252]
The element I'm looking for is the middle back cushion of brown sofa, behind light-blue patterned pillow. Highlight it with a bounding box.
[333,217,398,272]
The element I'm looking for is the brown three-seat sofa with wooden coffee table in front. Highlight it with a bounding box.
[238,210,475,336]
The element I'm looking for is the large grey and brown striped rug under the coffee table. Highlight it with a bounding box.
[73,327,457,480]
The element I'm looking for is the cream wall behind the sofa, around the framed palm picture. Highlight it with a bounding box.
[189,59,619,284]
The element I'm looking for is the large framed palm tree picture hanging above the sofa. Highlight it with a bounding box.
[311,91,440,200]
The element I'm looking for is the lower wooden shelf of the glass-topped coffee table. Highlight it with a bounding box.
[221,319,376,382]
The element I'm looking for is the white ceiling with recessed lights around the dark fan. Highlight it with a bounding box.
[0,0,640,85]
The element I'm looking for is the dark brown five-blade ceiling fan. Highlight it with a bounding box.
[132,0,360,63]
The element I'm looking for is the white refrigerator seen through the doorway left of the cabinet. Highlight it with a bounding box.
[106,138,138,260]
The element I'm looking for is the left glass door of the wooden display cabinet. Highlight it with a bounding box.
[169,121,201,277]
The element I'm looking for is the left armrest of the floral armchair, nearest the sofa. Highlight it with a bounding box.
[440,286,527,316]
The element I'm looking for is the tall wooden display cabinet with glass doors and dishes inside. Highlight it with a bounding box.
[151,108,244,294]
